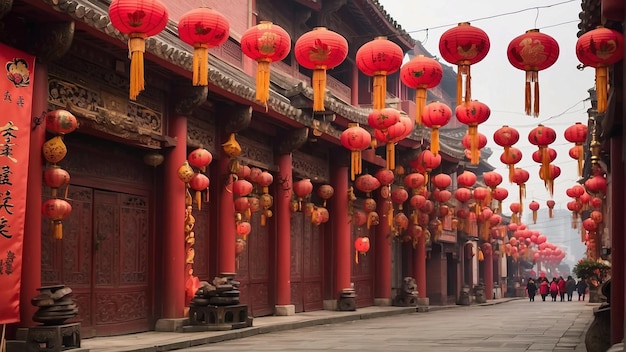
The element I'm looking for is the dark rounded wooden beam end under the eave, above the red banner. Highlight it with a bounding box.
[32,21,74,62]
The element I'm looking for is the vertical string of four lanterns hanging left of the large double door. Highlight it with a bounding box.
[41,110,78,240]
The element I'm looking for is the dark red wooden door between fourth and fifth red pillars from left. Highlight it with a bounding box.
[291,212,324,312]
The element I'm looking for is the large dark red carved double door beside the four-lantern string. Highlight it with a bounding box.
[42,185,152,337]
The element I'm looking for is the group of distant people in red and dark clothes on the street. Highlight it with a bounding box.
[526,276,587,302]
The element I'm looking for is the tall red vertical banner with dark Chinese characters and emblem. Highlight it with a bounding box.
[0,44,35,324]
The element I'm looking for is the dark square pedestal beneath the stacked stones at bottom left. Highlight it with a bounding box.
[26,323,80,352]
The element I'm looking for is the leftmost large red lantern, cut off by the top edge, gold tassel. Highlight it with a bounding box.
[109,0,168,100]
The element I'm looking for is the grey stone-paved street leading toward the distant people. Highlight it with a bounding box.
[181,299,597,352]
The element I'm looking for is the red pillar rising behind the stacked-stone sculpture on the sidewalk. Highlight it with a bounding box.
[217,143,237,274]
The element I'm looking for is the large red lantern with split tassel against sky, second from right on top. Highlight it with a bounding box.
[506,29,559,117]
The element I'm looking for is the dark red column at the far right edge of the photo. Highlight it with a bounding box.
[608,137,626,344]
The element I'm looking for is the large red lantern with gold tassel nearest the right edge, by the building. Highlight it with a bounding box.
[576,27,624,114]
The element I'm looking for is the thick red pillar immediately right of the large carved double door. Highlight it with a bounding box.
[161,115,187,319]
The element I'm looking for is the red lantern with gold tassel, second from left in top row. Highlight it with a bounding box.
[178,7,230,86]
